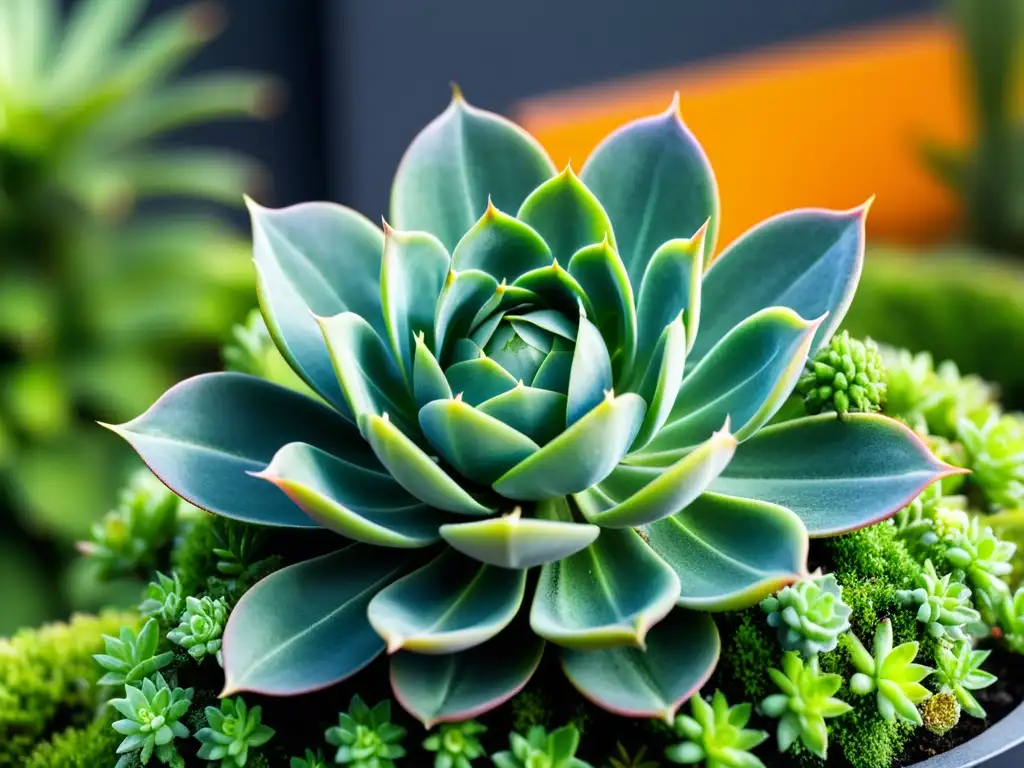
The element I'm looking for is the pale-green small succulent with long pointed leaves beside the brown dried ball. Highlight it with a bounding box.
[846,618,934,725]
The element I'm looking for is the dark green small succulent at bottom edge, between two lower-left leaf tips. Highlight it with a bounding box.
[325,695,406,768]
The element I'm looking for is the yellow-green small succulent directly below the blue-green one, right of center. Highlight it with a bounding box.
[761,651,852,760]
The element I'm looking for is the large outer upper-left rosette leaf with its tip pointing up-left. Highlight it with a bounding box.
[247,201,386,415]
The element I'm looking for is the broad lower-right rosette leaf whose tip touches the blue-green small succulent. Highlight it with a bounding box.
[644,494,807,610]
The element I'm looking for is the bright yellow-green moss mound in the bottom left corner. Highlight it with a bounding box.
[0,611,141,765]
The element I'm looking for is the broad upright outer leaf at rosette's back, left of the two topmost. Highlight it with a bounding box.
[391,90,555,250]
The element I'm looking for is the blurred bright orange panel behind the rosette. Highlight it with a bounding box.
[516,18,970,245]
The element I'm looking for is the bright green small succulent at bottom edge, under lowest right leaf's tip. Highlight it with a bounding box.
[665,691,768,768]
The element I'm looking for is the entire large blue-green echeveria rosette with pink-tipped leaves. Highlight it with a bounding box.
[108,96,951,725]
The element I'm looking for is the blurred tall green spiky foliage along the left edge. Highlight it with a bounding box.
[0,0,274,635]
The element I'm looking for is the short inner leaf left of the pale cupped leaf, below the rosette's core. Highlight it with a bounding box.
[420,399,540,485]
